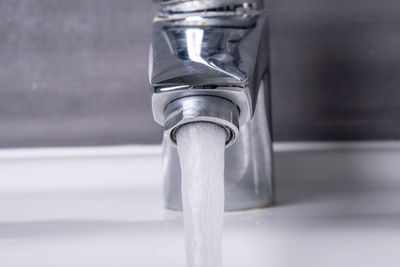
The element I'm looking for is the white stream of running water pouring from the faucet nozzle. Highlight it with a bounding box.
[177,122,226,267]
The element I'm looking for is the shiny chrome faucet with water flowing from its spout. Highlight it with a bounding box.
[149,0,274,211]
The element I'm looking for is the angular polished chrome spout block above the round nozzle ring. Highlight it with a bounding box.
[149,15,268,125]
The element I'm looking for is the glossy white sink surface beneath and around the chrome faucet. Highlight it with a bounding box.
[0,142,400,267]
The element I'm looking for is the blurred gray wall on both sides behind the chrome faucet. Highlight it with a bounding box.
[0,0,400,147]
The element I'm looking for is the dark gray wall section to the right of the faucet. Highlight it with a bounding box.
[270,0,400,140]
